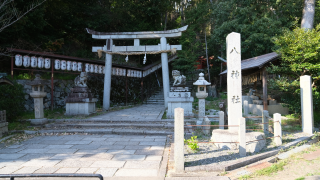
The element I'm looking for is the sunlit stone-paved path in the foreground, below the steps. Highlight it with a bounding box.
[0,135,166,178]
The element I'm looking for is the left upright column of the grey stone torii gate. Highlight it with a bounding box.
[103,39,113,110]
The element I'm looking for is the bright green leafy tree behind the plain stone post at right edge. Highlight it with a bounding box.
[268,24,320,118]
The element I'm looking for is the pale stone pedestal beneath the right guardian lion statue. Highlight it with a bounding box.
[167,92,194,118]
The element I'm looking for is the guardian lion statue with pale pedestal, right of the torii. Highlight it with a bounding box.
[167,70,193,118]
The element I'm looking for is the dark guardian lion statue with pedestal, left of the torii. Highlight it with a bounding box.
[65,72,98,115]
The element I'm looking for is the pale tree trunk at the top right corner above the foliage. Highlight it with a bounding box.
[301,0,316,29]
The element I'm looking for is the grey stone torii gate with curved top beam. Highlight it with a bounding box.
[87,26,188,110]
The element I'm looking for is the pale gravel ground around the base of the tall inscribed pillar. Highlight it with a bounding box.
[184,132,312,167]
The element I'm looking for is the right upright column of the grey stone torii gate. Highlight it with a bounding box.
[160,37,170,108]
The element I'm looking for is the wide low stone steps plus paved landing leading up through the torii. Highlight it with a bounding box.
[33,104,178,135]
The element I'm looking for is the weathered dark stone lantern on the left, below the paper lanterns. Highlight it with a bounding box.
[28,74,47,125]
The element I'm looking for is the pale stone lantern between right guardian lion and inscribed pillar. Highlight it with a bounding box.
[193,73,211,118]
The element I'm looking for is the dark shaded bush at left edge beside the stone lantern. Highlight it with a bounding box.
[0,81,25,122]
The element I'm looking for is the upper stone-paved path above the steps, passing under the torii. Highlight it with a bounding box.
[89,104,165,121]
